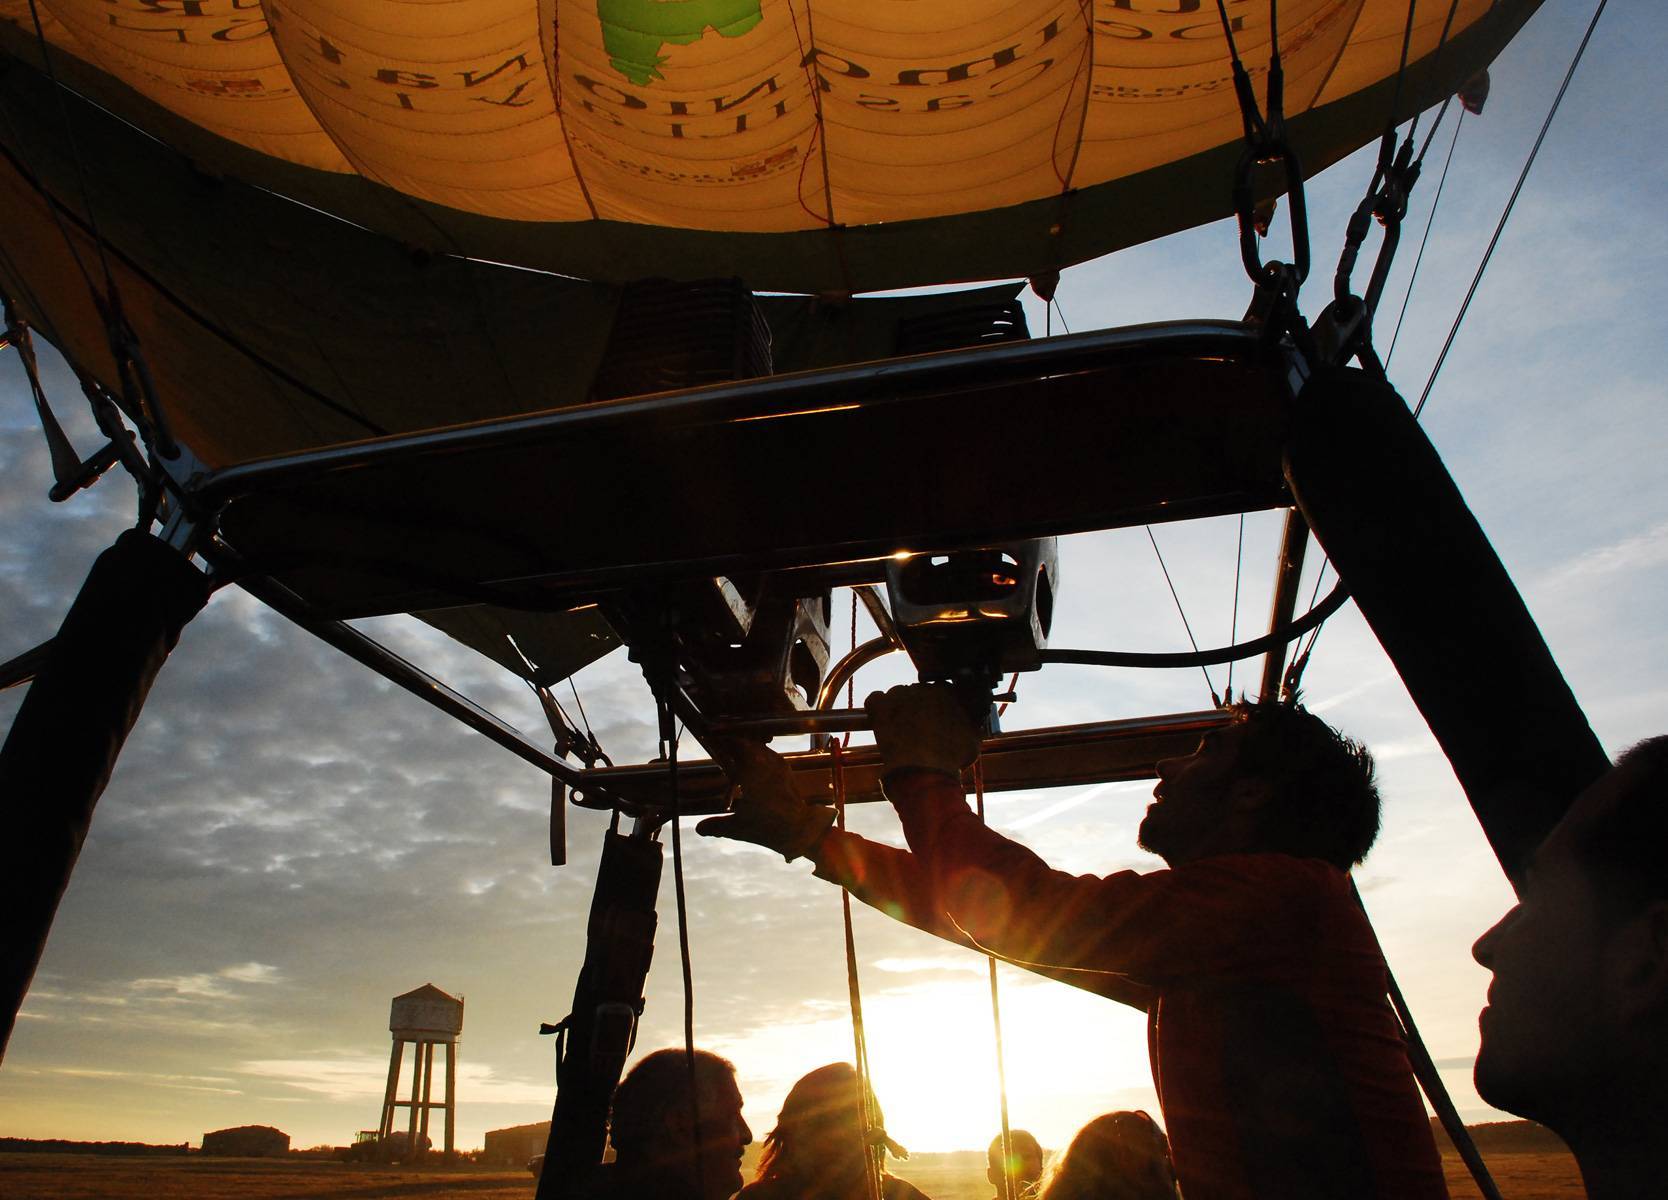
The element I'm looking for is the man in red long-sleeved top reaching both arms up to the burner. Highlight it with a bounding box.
[701,684,1448,1200]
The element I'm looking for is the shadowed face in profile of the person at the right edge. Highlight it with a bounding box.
[1471,771,1616,1123]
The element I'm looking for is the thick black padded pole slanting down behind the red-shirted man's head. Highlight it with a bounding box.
[1286,367,1610,883]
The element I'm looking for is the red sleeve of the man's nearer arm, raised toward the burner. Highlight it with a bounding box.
[887,771,1319,985]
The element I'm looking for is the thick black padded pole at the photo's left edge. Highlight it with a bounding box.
[0,529,209,1056]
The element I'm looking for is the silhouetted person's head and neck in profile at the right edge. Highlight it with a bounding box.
[1471,736,1668,1200]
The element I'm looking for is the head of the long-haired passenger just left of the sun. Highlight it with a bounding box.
[757,1063,902,1195]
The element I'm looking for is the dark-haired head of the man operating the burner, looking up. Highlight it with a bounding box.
[1138,701,1379,871]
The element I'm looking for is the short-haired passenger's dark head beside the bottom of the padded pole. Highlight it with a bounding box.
[609,1050,752,1200]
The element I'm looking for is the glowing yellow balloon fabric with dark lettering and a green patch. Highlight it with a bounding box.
[0,0,1536,287]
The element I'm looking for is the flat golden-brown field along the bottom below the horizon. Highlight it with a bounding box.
[0,1152,1586,1200]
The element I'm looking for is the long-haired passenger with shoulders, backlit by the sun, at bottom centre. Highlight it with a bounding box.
[741,1063,927,1200]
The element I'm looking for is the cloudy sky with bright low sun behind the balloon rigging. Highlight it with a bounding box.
[0,0,1668,1150]
